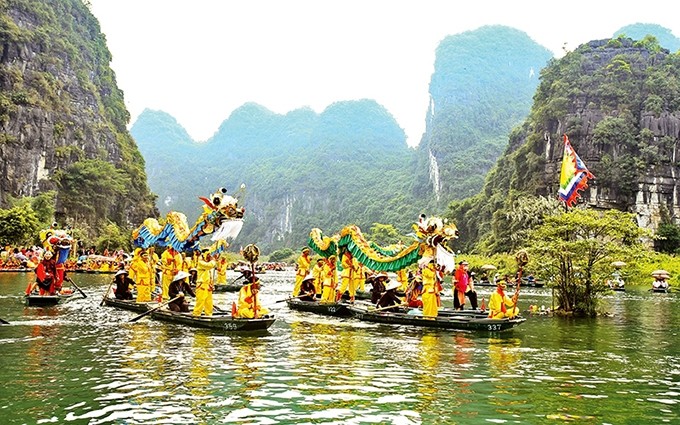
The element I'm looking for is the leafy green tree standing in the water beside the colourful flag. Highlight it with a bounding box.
[529,209,649,316]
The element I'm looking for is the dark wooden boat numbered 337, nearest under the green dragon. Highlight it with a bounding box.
[348,305,526,332]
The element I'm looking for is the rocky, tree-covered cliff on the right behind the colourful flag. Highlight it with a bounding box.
[453,36,680,250]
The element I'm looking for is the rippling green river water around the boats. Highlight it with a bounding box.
[0,272,680,424]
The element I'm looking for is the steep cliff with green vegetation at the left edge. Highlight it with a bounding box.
[0,0,155,230]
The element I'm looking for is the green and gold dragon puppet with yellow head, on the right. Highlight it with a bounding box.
[308,216,458,272]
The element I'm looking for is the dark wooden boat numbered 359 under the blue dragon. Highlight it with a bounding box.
[151,309,276,331]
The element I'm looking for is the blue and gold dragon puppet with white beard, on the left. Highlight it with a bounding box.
[132,188,245,254]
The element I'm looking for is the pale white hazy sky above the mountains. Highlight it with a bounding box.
[90,0,680,146]
